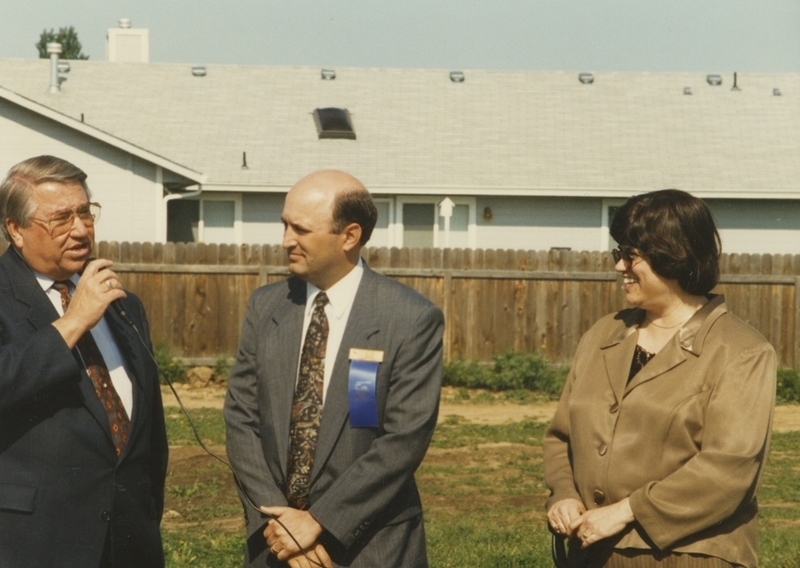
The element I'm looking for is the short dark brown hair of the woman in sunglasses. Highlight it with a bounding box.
[610,189,721,296]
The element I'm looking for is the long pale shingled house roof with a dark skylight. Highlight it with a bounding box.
[0,59,800,198]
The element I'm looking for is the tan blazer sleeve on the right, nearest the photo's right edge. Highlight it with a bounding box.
[630,342,776,549]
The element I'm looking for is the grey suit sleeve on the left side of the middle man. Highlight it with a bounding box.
[224,295,287,534]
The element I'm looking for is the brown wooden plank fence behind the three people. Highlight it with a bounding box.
[6,242,800,367]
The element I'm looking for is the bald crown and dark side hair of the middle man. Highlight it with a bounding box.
[290,170,378,246]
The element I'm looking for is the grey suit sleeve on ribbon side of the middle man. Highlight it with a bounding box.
[310,304,444,547]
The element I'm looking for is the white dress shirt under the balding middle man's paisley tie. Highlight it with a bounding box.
[297,259,364,404]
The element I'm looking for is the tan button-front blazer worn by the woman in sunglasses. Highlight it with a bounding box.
[543,296,776,567]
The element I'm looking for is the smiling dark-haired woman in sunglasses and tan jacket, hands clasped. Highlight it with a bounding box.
[544,190,776,568]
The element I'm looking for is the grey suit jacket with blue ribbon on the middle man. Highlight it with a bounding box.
[225,267,444,568]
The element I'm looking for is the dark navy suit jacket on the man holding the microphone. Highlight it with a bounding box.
[0,247,167,568]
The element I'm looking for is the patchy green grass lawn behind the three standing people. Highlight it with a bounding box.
[162,408,800,568]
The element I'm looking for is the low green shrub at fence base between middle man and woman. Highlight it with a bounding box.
[444,351,569,398]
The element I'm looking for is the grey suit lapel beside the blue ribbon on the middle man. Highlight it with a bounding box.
[311,266,380,484]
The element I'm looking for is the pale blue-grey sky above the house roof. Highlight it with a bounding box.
[0,0,800,72]
